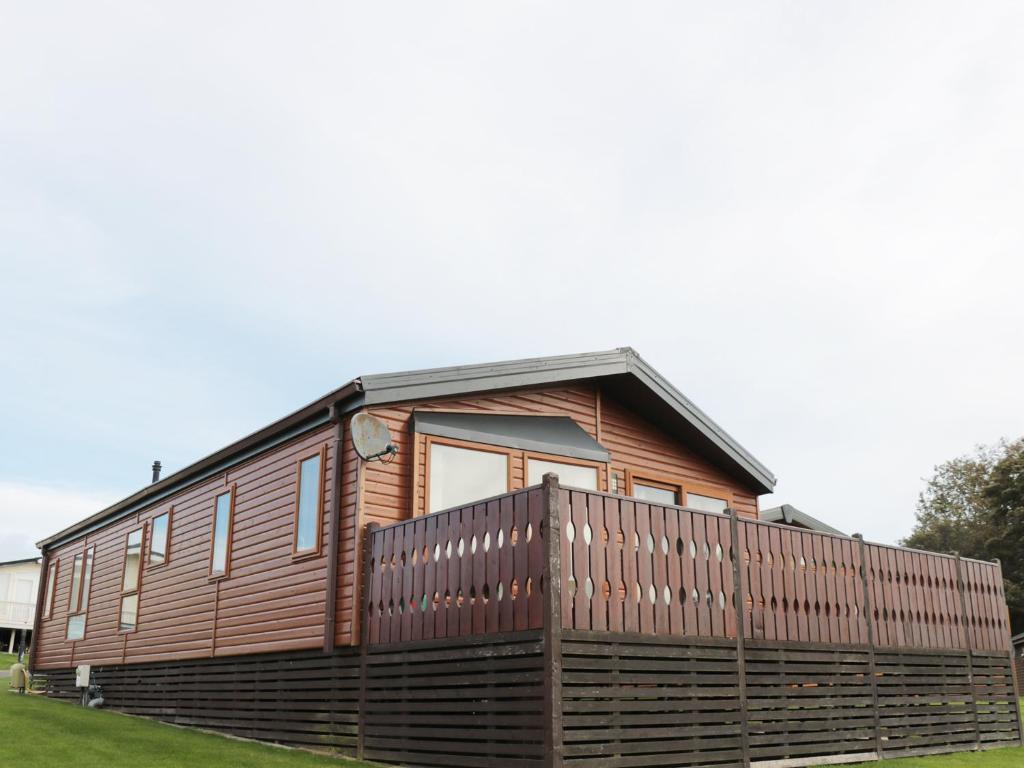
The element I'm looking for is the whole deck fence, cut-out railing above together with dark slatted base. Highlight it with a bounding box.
[357,476,1024,768]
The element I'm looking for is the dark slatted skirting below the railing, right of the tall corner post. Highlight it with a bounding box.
[562,630,1020,768]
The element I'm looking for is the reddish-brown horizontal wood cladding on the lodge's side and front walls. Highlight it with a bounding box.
[37,383,770,667]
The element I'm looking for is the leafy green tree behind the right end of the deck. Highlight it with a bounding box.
[901,438,1024,632]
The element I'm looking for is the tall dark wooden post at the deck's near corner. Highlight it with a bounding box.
[541,472,562,768]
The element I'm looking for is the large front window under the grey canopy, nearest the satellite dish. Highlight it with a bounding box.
[427,441,509,512]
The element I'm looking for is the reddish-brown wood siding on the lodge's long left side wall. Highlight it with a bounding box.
[34,429,333,669]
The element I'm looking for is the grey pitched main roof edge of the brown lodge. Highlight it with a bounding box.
[38,347,775,548]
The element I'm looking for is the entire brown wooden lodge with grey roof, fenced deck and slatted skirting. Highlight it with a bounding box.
[31,349,1021,768]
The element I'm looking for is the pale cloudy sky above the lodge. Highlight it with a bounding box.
[0,0,1024,560]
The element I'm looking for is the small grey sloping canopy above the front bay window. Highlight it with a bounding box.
[409,411,609,462]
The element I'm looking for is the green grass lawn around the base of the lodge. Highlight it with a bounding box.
[0,679,1024,768]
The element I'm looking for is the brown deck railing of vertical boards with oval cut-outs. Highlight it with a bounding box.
[364,477,1009,650]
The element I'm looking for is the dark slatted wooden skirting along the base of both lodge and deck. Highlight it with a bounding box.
[32,630,1020,768]
